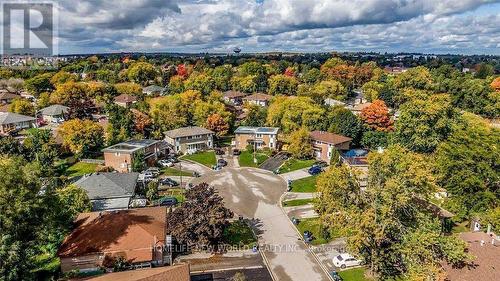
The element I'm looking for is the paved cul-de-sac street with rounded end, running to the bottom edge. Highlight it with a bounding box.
[193,167,330,281]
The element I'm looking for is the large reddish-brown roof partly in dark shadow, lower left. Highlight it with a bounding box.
[58,207,167,263]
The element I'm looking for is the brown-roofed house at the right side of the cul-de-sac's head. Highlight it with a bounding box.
[310,131,352,163]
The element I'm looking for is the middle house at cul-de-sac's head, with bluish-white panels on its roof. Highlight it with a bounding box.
[233,126,279,150]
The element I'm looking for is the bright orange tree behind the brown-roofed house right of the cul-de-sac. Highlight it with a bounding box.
[361,100,394,132]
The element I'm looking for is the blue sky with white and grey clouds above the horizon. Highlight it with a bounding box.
[48,0,500,55]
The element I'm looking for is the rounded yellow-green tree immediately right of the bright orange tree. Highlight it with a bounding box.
[394,94,456,153]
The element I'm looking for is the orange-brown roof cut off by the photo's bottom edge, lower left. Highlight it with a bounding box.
[85,263,191,281]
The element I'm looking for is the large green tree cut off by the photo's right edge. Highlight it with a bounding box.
[436,113,500,218]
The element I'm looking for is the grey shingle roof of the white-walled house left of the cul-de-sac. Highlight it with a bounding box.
[75,173,139,200]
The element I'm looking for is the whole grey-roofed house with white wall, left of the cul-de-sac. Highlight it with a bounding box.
[75,173,139,211]
